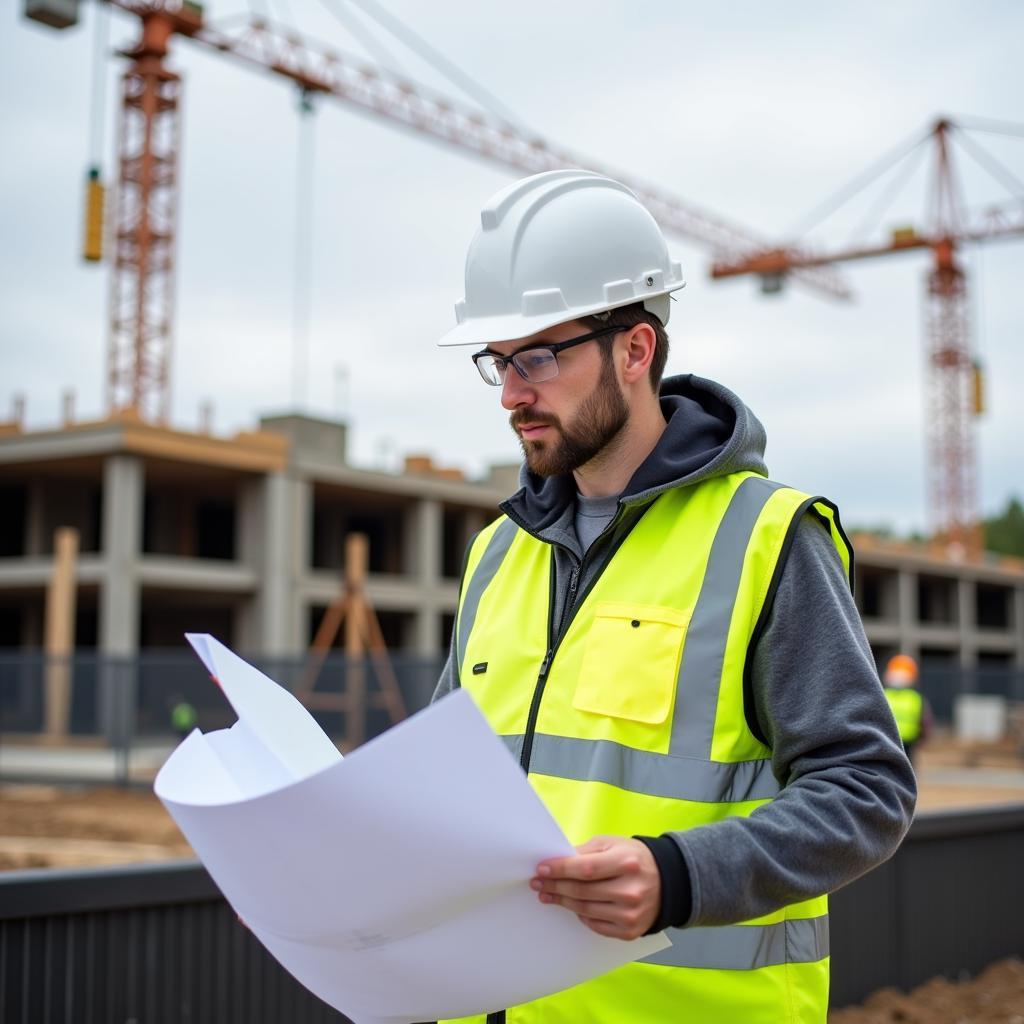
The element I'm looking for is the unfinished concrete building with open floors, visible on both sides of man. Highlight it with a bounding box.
[0,407,1024,669]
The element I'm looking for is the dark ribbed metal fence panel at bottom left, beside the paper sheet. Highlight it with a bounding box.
[0,861,350,1024]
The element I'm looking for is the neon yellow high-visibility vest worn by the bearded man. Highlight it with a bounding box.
[444,473,852,1024]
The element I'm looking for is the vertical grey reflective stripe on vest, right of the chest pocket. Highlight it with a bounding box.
[669,476,782,761]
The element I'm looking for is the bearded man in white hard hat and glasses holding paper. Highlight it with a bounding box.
[435,170,915,1024]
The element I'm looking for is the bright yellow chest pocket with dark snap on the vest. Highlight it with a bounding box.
[572,602,690,725]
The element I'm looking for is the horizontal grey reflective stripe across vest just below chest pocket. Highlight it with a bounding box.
[502,733,779,804]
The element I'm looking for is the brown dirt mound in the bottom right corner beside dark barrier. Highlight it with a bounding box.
[828,957,1024,1024]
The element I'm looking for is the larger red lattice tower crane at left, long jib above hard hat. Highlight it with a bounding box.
[25,0,849,421]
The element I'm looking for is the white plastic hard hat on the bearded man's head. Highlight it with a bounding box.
[438,170,686,345]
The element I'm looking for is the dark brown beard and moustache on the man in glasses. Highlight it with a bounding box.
[509,359,630,476]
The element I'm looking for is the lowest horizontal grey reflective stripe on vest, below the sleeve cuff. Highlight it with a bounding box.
[640,915,828,971]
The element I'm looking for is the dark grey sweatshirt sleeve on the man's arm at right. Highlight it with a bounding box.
[659,514,916,926]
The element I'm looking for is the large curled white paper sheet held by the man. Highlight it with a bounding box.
[155,634,669,1024]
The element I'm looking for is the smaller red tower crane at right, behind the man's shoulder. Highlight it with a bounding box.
[711,119,1024,557]
